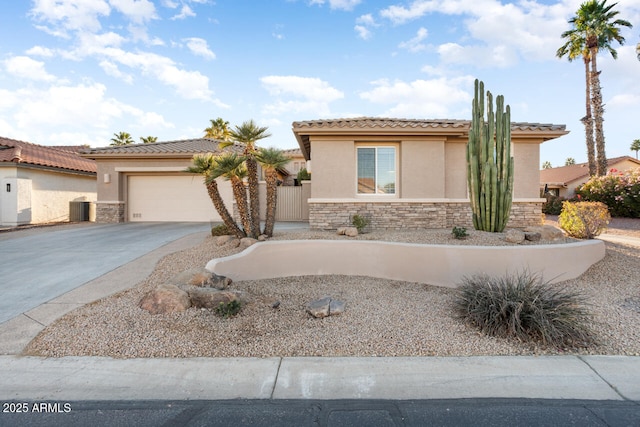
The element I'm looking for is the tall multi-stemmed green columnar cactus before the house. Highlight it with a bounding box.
[467,80,513,232]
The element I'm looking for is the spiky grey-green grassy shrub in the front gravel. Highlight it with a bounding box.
[454,272,595,348]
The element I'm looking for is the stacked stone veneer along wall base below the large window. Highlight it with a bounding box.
[309,201,543,230]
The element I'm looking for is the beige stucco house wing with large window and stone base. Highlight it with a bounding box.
[293,117,568,229]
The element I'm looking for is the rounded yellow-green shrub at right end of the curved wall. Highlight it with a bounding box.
[558,202,611,239]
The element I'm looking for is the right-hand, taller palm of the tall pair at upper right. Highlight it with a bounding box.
[569,0,632,176]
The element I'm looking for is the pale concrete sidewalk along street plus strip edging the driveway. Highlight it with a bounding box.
[0,222,640,408]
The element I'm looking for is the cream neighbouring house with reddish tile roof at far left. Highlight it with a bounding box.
[0,137,96,226]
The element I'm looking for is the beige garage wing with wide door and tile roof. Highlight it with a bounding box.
[83,138,241,222]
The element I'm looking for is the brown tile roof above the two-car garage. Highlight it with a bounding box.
[83,138,243,158]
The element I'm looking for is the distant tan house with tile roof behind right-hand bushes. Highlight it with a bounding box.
[540,156,640,199]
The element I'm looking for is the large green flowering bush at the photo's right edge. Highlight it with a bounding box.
[576,168,640,218]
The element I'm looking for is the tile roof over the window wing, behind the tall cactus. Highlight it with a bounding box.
[293,117,566,131]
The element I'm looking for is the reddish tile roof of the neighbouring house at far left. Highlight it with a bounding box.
[0,137,97,173]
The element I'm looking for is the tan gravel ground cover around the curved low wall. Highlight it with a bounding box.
[25,218,640,358]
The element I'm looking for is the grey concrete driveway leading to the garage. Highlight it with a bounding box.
[0,223,210,323]
